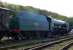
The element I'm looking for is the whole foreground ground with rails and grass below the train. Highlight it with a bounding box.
[0,35,73,50]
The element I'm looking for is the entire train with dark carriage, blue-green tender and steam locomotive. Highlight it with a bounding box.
[0,8,69,40]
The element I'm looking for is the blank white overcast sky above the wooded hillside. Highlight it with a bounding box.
[0,0,73,17]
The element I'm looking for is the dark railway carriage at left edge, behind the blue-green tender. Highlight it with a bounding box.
[0,7,14,39]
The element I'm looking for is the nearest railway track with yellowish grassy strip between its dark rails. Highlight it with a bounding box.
[28,36,73,50]
